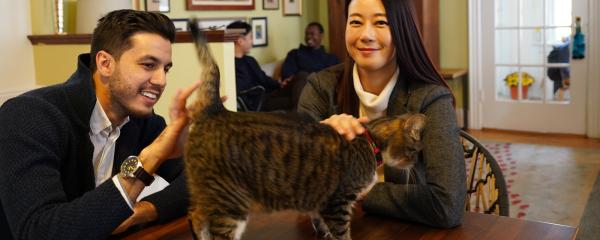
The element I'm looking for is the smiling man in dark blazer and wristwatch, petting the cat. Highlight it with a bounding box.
[0,10,197,239]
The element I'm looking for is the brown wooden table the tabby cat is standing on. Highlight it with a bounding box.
[125,209,577,240]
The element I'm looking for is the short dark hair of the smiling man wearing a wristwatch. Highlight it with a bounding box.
[90,9,175,72]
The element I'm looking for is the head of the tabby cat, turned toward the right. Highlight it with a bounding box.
[373,114,425,168]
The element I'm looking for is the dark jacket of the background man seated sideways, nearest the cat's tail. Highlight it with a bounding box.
[235,55,280,110]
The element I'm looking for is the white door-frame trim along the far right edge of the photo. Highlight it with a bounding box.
[586,0,600,138]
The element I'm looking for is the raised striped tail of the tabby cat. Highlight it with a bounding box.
[188,18,224,113]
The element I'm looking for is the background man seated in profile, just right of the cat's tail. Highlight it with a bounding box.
[227,21,289,111]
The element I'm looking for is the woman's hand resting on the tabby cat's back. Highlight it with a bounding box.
[321,113,369,141]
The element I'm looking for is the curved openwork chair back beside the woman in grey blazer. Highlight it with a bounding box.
[460,130,509,216]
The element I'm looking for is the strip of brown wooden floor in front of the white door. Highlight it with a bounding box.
[468,129,600,149]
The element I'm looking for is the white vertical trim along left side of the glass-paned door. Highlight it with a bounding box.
[467,0,484,129]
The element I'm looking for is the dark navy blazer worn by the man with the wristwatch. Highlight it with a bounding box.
[0,54,188,239]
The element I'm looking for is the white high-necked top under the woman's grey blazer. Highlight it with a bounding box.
[352,63,399,120]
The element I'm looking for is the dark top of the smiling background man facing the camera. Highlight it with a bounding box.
[281,44,339,79]
